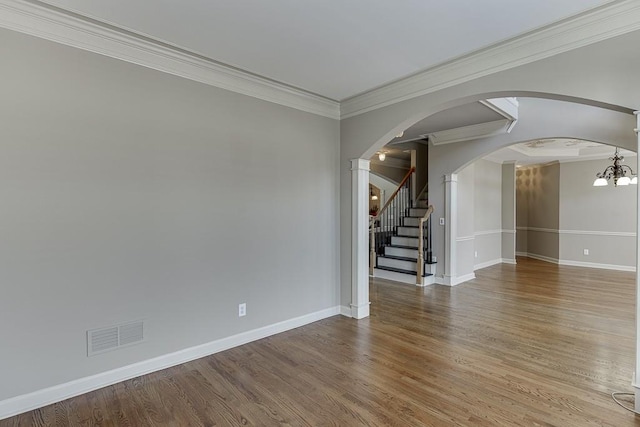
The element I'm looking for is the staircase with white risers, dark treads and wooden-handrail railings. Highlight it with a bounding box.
[370,170,435,286]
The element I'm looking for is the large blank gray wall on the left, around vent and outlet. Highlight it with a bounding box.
[0,30,339,400]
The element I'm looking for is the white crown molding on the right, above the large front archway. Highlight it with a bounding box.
[340,0,640,119]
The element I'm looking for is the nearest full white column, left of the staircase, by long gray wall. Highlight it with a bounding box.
[351,159,370,319]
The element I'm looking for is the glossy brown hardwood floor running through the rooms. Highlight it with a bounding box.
[0,258,640,427]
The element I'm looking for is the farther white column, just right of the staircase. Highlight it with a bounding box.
[443,173,458,286]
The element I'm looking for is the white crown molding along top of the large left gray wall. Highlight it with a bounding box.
[0,0,340,119]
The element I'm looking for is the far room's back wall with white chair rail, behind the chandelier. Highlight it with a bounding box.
[517,159,637,269]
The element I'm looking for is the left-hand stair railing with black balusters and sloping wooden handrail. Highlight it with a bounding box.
[369,168,416,276]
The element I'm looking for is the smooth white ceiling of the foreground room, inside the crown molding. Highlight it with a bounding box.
[38,0,610,100]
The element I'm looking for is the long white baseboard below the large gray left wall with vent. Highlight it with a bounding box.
[0,306,340,420]
